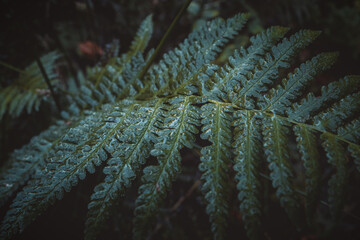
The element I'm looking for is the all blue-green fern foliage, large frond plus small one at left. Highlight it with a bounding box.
[0,0,360,239]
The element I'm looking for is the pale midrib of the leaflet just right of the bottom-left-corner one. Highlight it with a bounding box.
[92,99,163,219]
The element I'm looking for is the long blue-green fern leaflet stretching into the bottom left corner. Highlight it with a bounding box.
[0,102,136,239]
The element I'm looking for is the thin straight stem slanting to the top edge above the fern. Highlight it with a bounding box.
[138,0,192,79]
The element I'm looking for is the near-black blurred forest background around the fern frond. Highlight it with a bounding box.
[0,0,360,240]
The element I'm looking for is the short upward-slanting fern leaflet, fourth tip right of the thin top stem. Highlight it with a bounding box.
[260,53,338,114]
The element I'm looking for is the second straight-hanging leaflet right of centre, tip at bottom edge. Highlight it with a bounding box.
[233,110,262,239]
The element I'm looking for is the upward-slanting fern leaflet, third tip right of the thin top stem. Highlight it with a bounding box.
[231,30,320,107]
